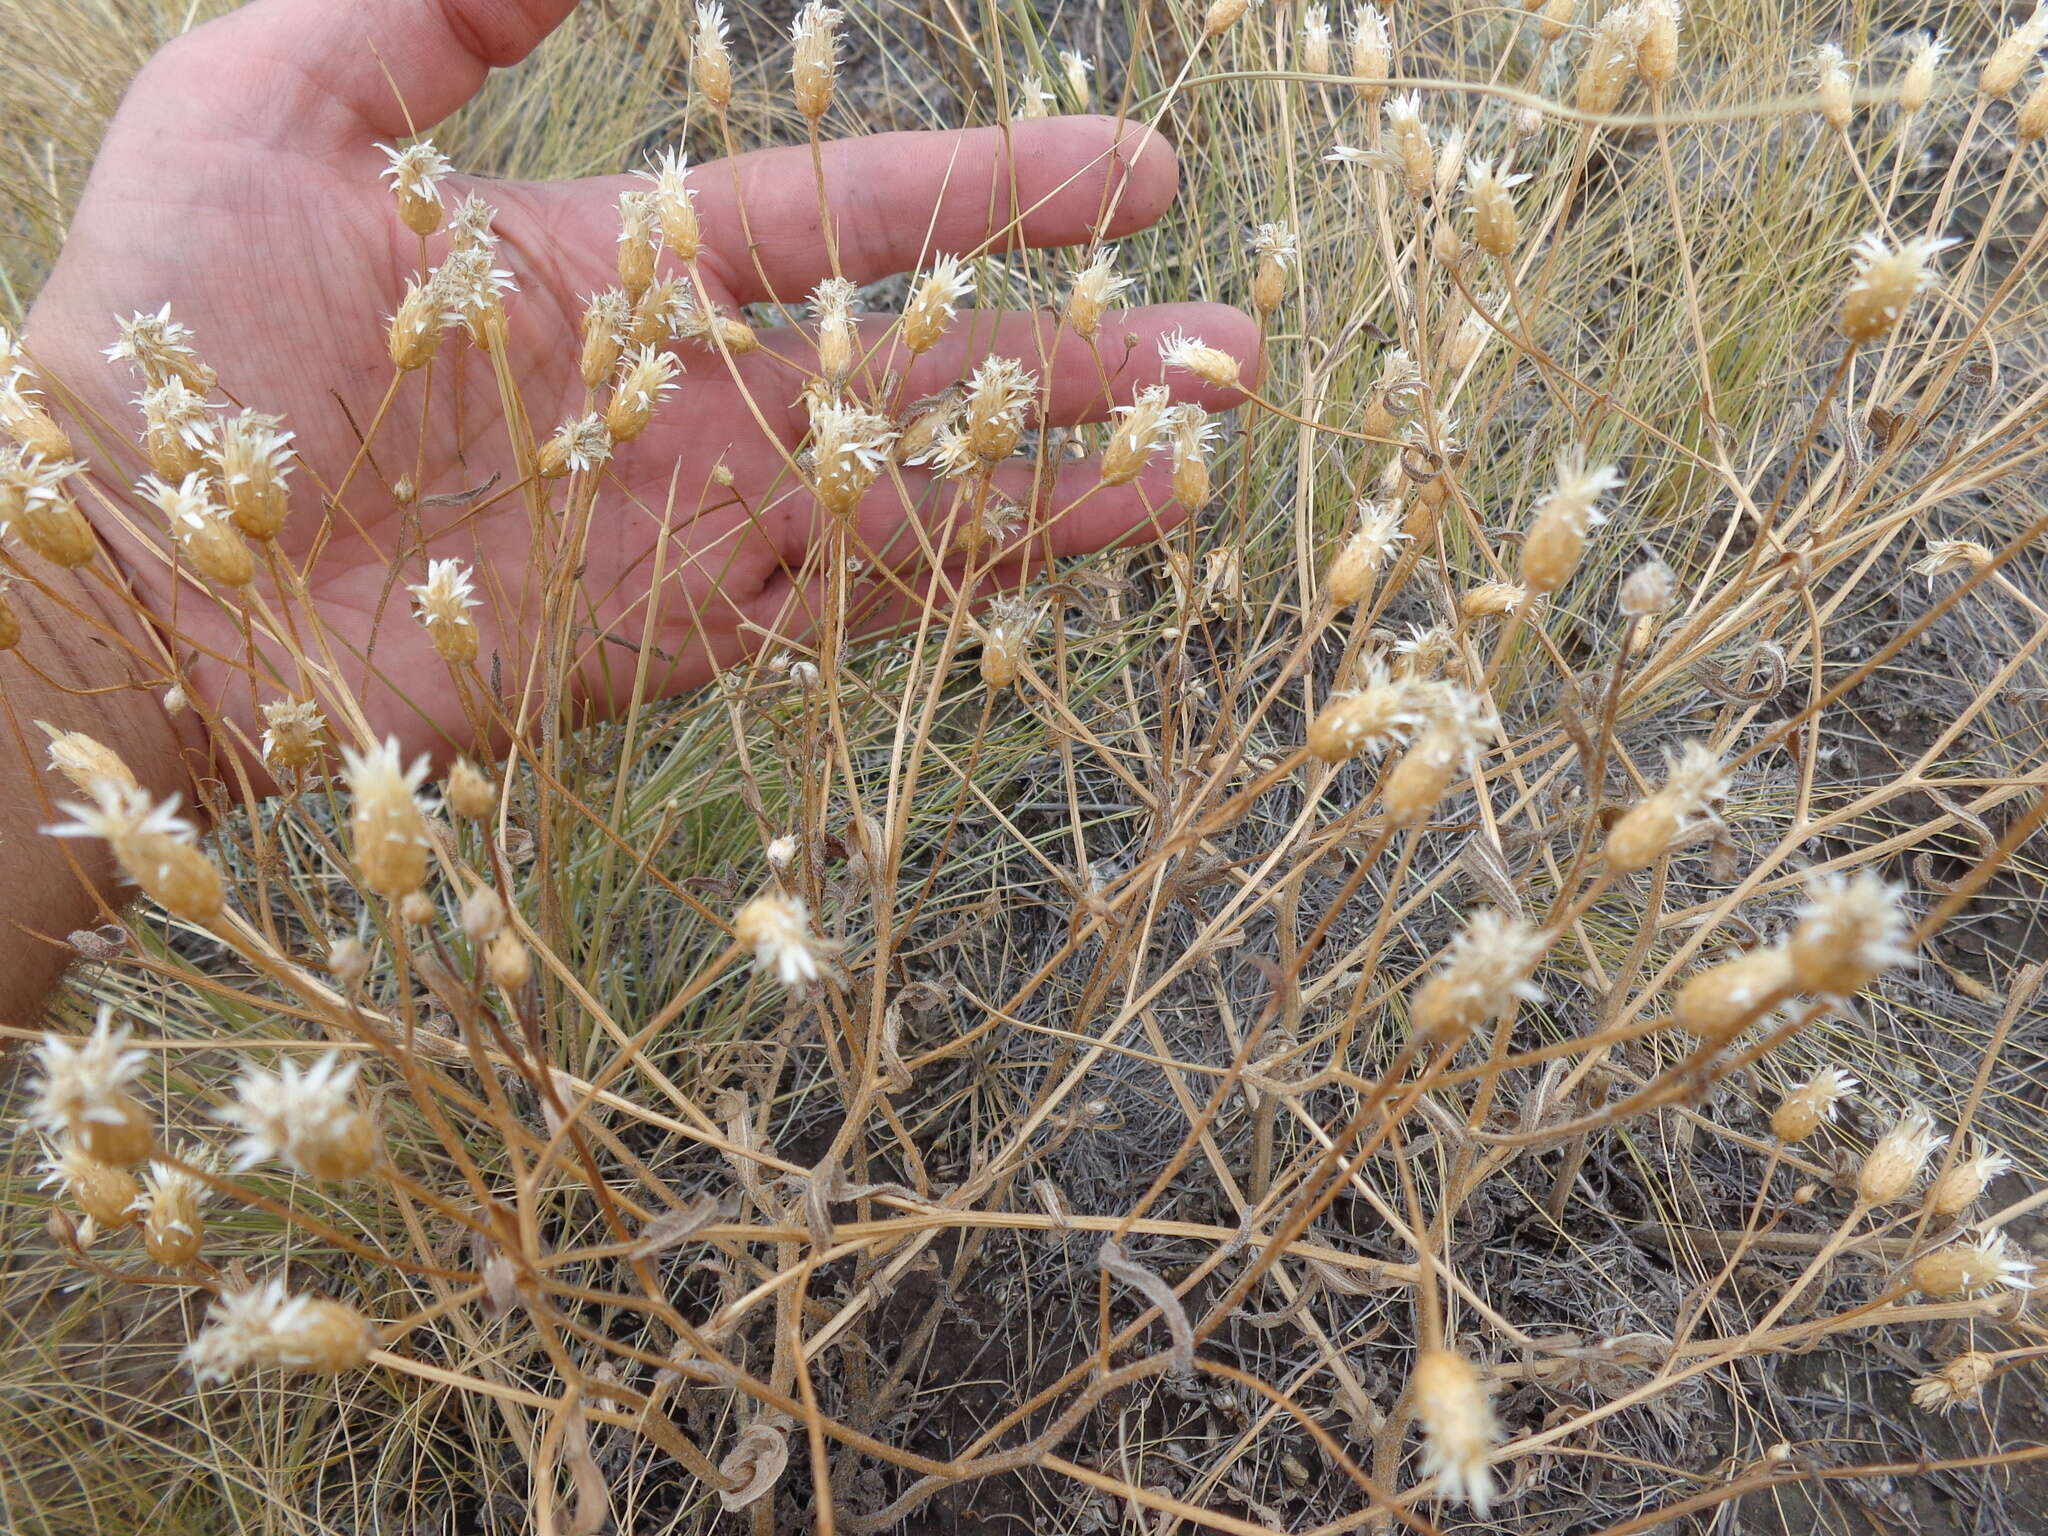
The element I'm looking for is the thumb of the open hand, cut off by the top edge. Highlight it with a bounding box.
[123,0,575,150]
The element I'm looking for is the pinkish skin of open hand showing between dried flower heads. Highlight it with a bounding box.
[29,0,1255,770]
